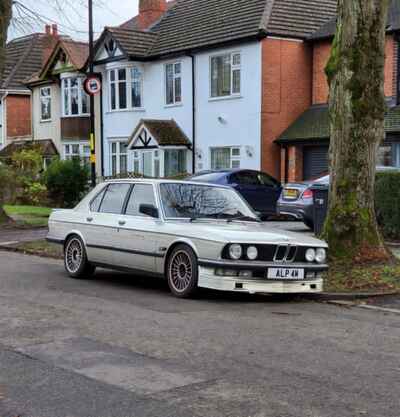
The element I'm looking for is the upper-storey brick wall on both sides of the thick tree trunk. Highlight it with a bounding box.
[313,35,397,104]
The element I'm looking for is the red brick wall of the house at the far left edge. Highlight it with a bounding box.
[6,95,32,139]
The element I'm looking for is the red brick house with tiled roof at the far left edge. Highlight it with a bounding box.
[0,25,58,156]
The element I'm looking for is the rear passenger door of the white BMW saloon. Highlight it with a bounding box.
[85,183,131,266]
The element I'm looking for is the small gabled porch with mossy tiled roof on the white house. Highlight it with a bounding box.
[128,119,192,177]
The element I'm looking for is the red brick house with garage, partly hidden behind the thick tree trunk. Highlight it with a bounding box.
[276,0,400,181]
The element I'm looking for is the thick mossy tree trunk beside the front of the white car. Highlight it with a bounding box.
[324,0,388,261]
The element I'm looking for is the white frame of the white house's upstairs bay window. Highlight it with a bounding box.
[107,65,144,112]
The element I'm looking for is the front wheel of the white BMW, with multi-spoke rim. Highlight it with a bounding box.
[167,245,199,298]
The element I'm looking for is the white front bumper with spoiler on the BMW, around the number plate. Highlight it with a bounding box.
[198,260,328,294]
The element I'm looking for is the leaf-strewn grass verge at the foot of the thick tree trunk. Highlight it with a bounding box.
[324,260,400,293]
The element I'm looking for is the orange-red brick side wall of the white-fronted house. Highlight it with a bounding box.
[261,38,312,180]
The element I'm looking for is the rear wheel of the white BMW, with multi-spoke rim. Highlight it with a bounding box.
[64,236,96,279]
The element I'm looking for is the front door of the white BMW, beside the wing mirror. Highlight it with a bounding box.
[112,183,162,272]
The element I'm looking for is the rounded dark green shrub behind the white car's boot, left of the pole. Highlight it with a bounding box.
[43,159,89,208]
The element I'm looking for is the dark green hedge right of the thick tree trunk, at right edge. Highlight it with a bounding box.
[375,171,400,239]
